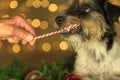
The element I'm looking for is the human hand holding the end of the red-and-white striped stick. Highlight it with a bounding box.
[0,16,36,45]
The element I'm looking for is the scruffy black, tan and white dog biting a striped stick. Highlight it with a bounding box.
[55,0,120,80]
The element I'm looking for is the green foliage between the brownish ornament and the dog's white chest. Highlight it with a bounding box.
[41,57,74,80]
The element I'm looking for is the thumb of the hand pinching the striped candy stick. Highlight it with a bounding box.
[14,27,34,41]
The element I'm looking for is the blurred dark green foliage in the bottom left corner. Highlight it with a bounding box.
[0,61,27,80]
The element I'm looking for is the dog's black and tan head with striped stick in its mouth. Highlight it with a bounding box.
[55,0,120,49]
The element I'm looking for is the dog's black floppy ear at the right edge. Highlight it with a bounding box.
[96,0,120,24]
